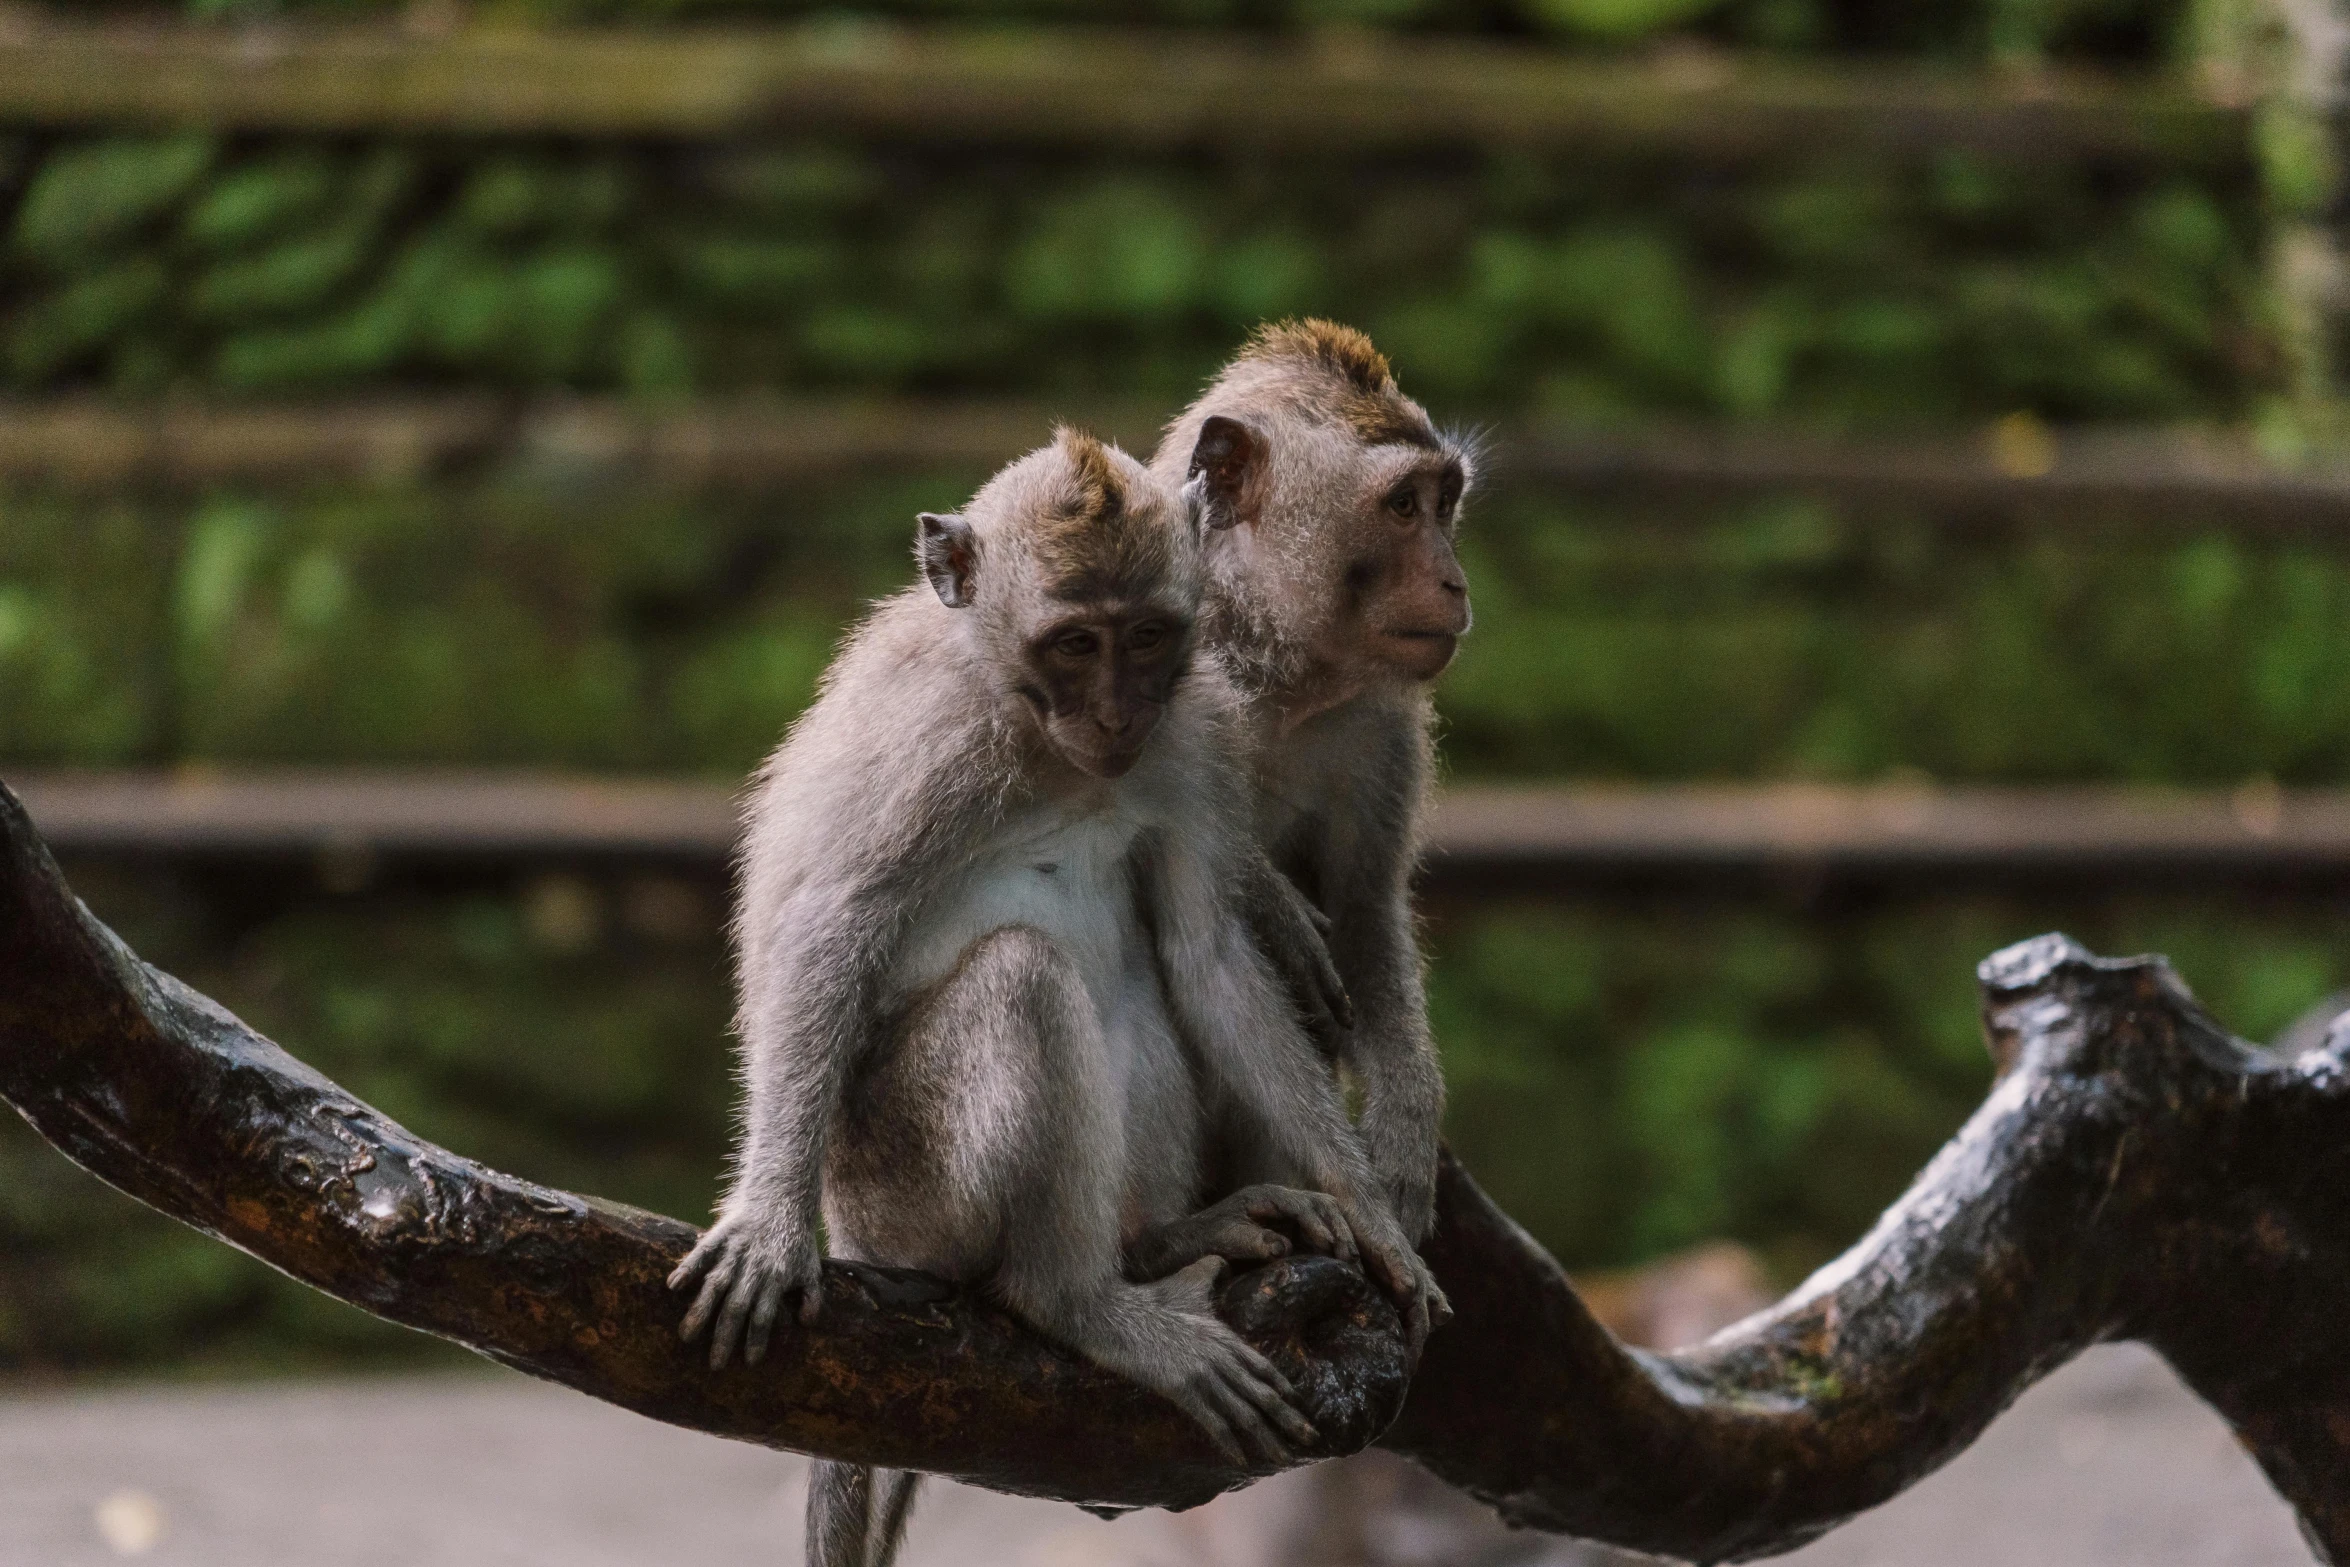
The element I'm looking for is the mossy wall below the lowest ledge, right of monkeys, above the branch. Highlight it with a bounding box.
[1429,895,2350,1278]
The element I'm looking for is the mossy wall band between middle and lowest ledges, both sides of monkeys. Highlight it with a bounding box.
[0,479,2350,785]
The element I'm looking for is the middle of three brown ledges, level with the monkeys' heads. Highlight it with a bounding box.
[0,395,2350,533]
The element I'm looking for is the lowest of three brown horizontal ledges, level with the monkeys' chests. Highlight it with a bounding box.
[18,766,2350,881]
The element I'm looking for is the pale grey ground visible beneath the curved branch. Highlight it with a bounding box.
[0,1346,2312,1567]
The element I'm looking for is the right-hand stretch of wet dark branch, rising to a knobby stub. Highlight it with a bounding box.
[1384,935,2350,1562]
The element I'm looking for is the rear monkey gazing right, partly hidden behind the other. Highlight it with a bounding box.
[1152,320,1476,1259]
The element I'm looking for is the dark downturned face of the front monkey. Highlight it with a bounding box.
[1020,601,1191,778]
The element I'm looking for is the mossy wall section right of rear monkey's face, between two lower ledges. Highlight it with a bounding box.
[1441,498,2350,785]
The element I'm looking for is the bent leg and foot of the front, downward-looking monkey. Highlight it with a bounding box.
[869,926,1314,1464]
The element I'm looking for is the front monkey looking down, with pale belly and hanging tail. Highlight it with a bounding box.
[670,430,1434,1567]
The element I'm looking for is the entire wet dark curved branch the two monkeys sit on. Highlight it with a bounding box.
[0,787,2350,1562]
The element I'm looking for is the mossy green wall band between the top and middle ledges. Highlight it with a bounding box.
[0,139,2287,425]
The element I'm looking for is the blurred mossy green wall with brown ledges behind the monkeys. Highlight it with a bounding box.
[0,0,2350,1560]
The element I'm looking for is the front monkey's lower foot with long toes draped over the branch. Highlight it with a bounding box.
[1128,1257,1321,1468]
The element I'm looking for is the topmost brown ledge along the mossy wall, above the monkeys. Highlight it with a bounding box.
[0,14,2247,162]
